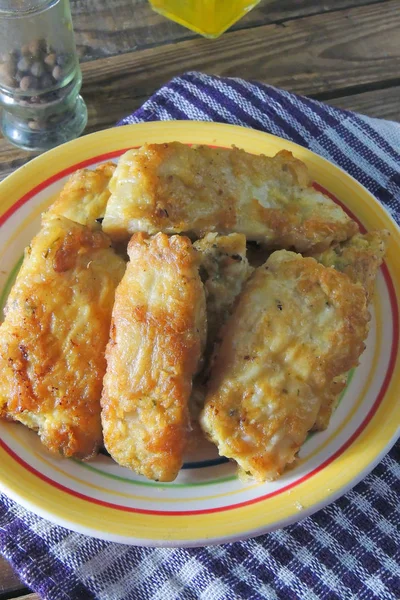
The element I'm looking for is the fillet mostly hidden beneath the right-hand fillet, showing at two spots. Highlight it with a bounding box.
[313,230,389,431]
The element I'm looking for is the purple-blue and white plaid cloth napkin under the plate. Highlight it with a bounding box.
[0,73,400,600]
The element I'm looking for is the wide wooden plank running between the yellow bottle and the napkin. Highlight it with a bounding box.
[0,0,400,177]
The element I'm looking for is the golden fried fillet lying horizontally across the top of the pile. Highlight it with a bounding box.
[103,142,358,252]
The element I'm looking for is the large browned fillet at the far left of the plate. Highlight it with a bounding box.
[0,216,125,458]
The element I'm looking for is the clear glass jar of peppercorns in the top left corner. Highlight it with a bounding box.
[0,0,87,150]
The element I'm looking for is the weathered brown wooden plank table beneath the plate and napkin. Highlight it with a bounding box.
[0,0,400,600]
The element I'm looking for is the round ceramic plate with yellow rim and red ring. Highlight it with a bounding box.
[0,122,400,546]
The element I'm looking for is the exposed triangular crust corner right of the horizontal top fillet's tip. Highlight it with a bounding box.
[312,229,389,301]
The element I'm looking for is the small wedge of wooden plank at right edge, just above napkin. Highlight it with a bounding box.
[329,86,400,121]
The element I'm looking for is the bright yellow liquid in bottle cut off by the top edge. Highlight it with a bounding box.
[150,0,260,38]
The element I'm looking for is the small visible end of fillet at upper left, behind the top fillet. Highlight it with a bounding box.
[47,162,116,229]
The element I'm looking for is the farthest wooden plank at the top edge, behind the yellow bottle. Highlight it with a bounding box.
[71,0,387,60]
